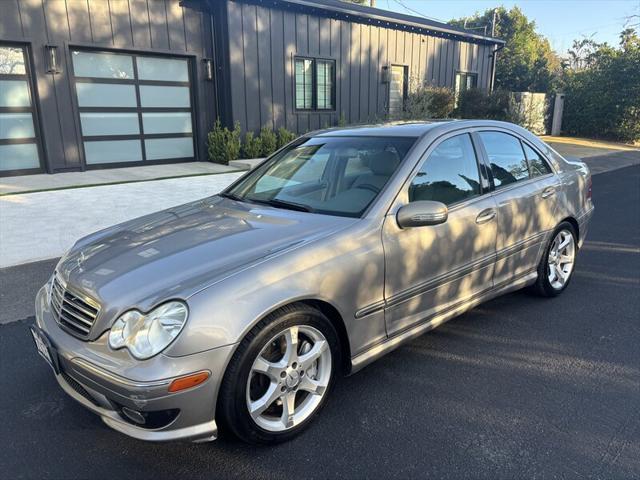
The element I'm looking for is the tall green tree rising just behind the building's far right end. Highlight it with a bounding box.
[449,7,562,92]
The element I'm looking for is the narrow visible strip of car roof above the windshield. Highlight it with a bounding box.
[307,120,457,138]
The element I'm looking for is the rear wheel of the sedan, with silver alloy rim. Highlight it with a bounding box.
[534,222,578,297]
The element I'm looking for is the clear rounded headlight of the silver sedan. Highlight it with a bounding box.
[109,301,189,360]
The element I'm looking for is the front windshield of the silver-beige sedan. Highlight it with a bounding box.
[221,136,416,217]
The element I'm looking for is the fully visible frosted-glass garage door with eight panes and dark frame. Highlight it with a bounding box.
[71,50,194,166]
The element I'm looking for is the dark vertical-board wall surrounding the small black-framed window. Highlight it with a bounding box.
[227,2,492,132]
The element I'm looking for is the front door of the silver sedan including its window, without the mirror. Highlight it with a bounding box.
[382,133,497,336]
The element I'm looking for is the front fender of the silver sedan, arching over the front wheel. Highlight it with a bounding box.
[165,221,386,356]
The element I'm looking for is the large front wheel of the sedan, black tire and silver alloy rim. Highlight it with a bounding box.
[216,304,340,444]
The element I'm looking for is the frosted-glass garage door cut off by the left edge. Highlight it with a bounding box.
[0,45,41,174]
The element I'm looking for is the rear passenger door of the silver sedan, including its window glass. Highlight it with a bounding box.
[477,130,558,287]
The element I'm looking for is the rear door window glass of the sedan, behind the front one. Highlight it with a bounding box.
[479,132,529,187]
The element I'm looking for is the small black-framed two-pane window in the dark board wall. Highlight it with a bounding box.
[295,58,336,110]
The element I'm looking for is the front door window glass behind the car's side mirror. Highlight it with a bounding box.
[409,134,480,205]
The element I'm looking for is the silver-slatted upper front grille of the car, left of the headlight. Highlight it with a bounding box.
[51,275,99,338]
